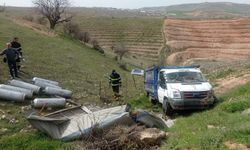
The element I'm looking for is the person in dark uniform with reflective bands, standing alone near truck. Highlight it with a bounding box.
[109,70,121,98]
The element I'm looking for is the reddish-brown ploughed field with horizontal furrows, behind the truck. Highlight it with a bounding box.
[164,19,250,64]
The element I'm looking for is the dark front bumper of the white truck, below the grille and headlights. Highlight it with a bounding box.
[169,97,215,110]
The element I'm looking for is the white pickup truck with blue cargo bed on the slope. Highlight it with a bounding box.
[144,66,215,115]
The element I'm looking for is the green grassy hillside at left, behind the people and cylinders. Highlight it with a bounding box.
[0,14,143,102]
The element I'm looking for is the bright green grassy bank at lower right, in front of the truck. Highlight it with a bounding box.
[130,83,250,150]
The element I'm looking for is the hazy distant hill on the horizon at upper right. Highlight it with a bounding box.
[140,2,250,18]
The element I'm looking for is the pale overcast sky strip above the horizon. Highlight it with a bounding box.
[0,0,250,9]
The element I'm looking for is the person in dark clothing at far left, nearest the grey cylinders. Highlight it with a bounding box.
[0,43,18,79]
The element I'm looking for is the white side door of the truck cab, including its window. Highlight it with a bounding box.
[157,72,167,103]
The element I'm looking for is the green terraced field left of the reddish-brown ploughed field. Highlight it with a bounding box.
[77,17,163,64]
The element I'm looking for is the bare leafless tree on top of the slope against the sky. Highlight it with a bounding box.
[33,0,72,29]
